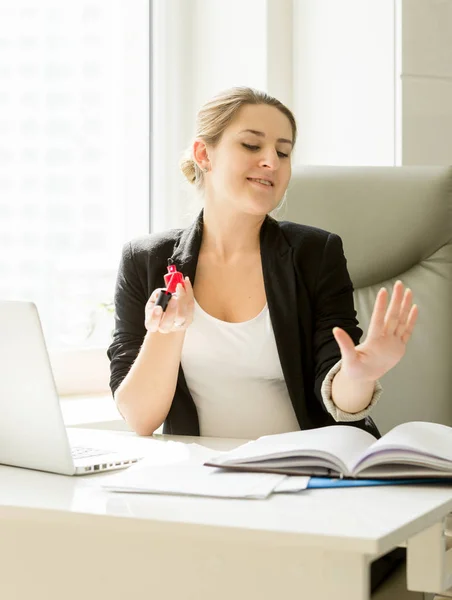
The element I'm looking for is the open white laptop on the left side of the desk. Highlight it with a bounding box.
[0,300,142,475]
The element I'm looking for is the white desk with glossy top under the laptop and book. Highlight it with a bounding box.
[0,431,452,600]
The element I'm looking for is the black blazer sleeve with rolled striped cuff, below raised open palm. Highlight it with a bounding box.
[314,233,382,421]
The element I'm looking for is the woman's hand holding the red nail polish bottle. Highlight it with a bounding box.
[144,277,195,333]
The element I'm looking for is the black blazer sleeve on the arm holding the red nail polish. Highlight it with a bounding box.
[107,242,147,395]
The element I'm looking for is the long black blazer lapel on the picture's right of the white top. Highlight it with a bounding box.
[260,217,311,429]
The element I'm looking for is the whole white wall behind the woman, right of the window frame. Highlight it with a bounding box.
[152,0,452,230]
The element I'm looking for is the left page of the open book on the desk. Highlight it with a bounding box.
[209,425,376,474]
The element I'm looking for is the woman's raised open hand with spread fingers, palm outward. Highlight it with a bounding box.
[333,281,418,381]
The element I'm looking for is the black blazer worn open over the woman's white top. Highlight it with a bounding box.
[107,212,380,437]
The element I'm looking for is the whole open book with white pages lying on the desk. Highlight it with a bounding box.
[205,421,452,479]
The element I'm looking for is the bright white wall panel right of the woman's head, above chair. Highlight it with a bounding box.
[292,0,395,165]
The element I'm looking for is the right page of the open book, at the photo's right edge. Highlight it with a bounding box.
[354,421,452,473]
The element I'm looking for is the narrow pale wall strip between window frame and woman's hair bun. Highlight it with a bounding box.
[151,0,195,231]
